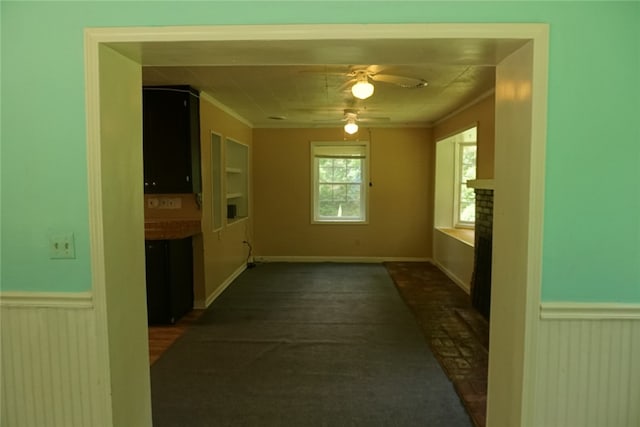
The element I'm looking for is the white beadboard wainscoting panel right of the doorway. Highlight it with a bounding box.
[534,303,640,427]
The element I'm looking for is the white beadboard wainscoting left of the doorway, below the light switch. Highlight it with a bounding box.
[0,293,106,427]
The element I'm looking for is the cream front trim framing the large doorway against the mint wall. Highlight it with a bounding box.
[85,24,548,425]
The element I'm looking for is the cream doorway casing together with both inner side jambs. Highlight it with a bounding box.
[85,24,548,425]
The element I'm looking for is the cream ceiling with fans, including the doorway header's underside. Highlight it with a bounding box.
[110,39,525,128]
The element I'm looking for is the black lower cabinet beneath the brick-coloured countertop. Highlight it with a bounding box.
[145,237,193,325]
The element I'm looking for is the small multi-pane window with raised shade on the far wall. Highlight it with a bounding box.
[311,141,369,223]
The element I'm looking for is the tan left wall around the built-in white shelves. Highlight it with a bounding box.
[194,96,253,306]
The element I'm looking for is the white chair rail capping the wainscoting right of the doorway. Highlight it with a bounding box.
[540,301,640,320]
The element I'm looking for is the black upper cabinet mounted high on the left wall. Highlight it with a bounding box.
[142,86,201,194]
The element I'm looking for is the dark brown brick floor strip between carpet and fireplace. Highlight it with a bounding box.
[385,262,489,427]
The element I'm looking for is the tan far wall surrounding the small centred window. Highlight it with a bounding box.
[253,128,434,258]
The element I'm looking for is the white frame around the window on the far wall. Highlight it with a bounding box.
[309,141,370,225]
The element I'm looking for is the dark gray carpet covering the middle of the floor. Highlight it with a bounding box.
[151,263,471,427]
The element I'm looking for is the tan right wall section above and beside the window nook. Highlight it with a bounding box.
[433,93,495,179]
